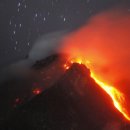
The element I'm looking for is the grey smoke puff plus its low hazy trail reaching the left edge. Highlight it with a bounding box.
[0,31,67,82]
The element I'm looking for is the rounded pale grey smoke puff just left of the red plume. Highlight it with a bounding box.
[29,31,66,61]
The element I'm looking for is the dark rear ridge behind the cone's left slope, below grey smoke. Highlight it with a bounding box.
[0,54,66,122]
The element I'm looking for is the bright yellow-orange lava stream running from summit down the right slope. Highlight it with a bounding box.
[67,58,130,121]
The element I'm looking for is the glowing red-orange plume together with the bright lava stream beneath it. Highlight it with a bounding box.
[59,9,130,121]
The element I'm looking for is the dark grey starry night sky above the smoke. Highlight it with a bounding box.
[0,0,130,67]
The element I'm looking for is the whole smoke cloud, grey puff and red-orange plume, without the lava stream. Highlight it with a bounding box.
[1,9,130,102]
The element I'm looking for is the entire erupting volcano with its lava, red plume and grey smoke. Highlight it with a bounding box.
[0,5,130,130]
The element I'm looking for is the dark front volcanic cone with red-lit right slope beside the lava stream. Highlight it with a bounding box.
[1,63,130,130]
